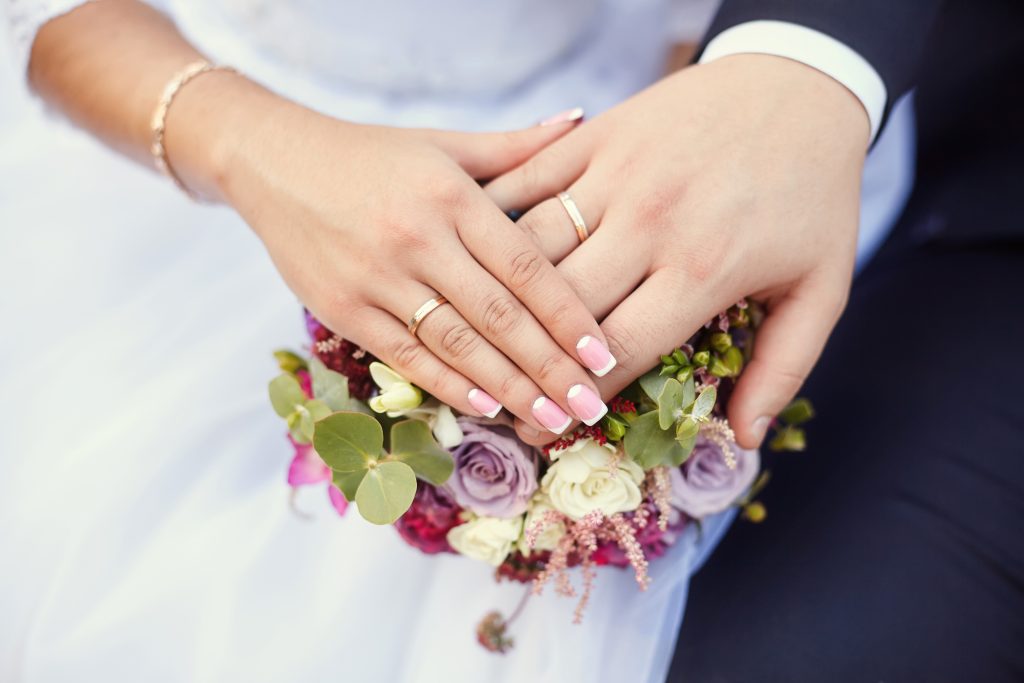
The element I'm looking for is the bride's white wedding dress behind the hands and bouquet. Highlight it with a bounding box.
[0,0,913,683]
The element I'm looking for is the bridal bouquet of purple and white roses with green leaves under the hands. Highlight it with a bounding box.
[269,301,812,651]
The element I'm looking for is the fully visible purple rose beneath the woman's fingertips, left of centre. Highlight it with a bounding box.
[444,418,537,517]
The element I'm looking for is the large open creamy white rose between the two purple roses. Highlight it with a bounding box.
[541,438,644,519]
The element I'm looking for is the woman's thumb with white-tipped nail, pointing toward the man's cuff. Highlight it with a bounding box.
[430,108,583,180]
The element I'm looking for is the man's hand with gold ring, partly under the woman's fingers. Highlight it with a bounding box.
[486,55,868,447]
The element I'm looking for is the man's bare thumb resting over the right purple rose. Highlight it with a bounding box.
[728,279,849,449]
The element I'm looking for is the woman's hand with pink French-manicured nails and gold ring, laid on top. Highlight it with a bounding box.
[180,75,603,431]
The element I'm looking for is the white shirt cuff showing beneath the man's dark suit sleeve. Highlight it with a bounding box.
[700,20,888,141]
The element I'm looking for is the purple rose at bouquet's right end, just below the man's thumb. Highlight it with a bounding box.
[670,436,761,519]
